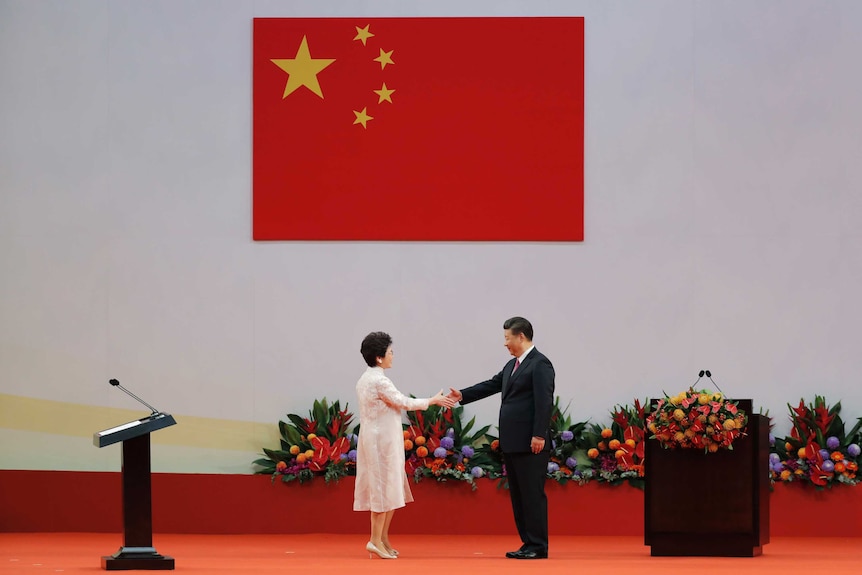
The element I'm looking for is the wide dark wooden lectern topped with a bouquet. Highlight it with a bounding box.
[644,399,769,557]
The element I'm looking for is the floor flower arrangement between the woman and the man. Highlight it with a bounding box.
[404,405,493,489]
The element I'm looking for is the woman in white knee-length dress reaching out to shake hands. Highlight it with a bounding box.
[353,331,454,559]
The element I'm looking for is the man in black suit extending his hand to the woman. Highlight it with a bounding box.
[449,317,554,559]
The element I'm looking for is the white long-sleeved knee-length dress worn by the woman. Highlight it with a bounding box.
[353,367,428,513]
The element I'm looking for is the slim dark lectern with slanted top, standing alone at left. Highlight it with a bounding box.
[93,413,176,571]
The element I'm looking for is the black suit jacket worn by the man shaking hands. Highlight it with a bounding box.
[461,348,554,453]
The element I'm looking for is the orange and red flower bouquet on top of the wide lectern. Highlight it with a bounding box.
[646,388,748,453]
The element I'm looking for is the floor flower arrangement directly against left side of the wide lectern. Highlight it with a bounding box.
[581,399,645,489]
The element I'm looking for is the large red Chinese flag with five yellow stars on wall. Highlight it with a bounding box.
[253,18,584,241]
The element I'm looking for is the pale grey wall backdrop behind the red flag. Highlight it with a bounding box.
[0,0,862,473]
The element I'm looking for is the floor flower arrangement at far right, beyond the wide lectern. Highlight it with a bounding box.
[769,395,862,489]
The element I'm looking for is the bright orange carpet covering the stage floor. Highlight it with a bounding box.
[0,536,862,575]
